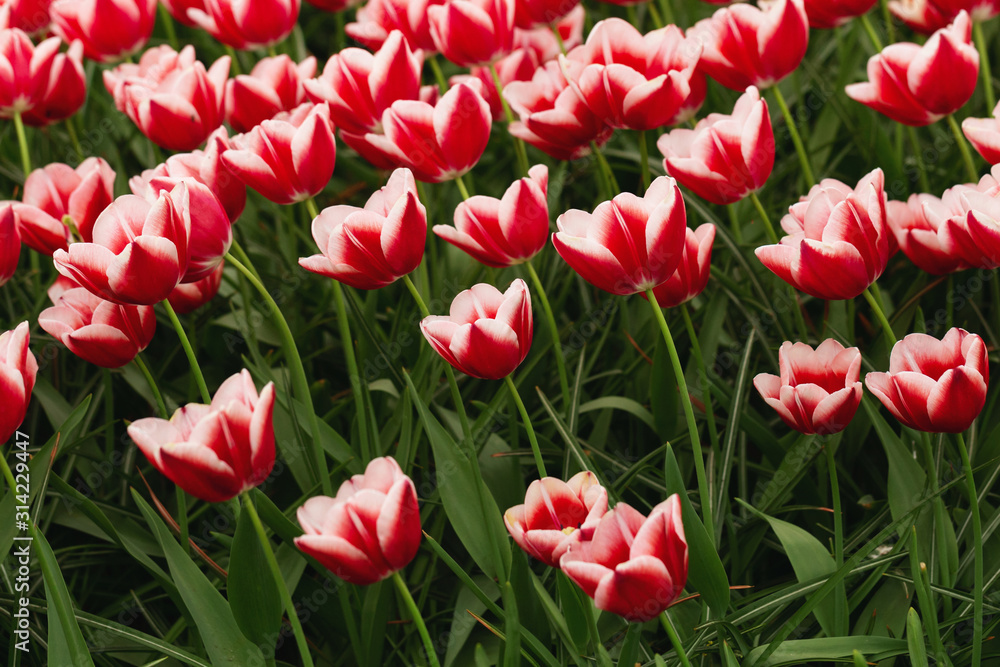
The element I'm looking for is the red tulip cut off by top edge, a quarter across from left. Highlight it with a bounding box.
[188,0,301,50]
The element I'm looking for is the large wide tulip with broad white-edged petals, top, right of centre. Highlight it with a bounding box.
[561,18,701,130]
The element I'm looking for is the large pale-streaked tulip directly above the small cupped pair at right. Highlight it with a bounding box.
[756,169,891,300]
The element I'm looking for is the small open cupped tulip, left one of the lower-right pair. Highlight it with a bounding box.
[753,338,862,435]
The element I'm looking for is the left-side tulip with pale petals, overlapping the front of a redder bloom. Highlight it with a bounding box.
[52,185,190,306]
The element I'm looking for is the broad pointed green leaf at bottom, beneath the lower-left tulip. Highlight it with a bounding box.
[132,489,264,667]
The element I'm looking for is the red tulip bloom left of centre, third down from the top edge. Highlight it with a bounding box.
[222,104,337,204]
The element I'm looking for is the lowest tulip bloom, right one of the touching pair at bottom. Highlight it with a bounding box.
[559,493,688,622]
